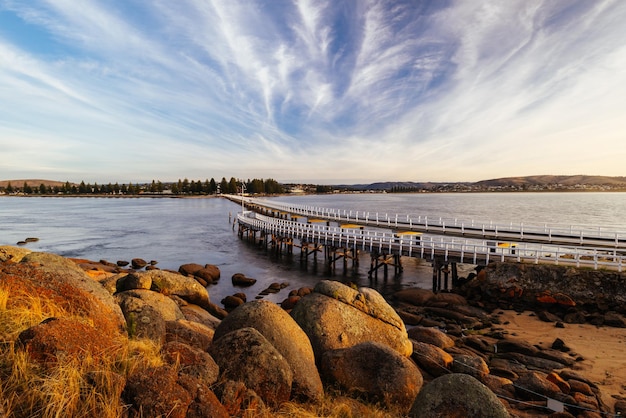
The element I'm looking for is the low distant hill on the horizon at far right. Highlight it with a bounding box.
[474,175,626,187]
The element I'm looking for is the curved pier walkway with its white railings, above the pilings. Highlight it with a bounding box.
[225,195,626,273]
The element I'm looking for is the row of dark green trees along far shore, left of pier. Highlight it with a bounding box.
[0,177,285,196]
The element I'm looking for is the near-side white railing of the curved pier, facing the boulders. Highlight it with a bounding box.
[237,211,626,272]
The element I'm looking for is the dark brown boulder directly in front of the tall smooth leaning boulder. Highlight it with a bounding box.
[210,328,293,408]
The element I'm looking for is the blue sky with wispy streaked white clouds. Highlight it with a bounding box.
[0,0,626,184]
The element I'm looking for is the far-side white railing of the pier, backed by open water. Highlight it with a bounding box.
[228,195,626,251]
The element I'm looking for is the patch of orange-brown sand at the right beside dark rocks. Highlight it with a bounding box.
[499,311,626,406]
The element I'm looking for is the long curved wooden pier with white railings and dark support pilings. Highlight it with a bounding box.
[229,197,626,291]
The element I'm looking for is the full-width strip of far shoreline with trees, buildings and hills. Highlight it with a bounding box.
[0,176,626,196]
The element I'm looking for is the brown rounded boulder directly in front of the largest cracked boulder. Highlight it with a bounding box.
[321,342,423,413]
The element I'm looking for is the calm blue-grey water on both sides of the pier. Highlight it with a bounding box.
[0,193,626,303]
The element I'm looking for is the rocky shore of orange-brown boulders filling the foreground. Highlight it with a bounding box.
[0,243,626,417]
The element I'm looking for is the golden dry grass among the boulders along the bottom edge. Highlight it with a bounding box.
[0,285,402,418]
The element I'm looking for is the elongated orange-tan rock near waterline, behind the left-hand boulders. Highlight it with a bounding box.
[132,270,210,309]
